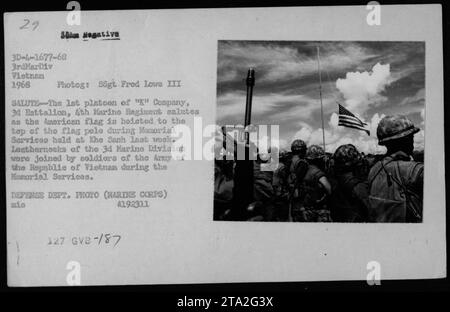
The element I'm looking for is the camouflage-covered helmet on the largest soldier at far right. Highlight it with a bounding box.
[377,115,420,145]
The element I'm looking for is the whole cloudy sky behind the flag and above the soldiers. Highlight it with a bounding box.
[217,41,425,153]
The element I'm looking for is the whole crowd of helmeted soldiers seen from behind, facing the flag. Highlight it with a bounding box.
[214,115,424,222]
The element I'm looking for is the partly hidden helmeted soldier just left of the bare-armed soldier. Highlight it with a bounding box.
[288,139,308,221]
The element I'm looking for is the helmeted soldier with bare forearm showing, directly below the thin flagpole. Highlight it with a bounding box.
[299,145,331,222]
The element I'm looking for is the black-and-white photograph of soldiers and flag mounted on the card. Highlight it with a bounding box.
[214,40,426,223]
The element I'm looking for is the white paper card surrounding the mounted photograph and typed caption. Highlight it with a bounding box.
[5,5,446,286]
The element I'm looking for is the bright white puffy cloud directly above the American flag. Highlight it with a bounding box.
[336,63,393,113]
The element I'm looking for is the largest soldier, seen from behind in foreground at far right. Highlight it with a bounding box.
[368,115,424,222]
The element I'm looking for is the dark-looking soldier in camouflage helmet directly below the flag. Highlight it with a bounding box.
[330,144,369,222]
